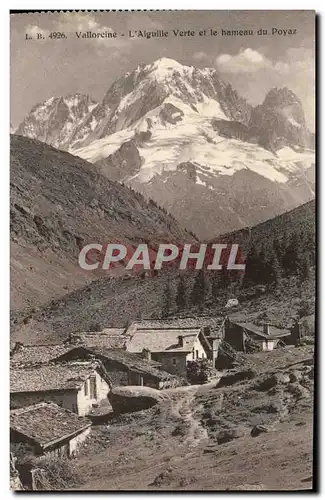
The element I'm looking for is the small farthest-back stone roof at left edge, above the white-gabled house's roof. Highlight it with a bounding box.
[10,344,71,365]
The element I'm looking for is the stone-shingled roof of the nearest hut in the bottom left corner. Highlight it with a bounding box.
[10,403,91,448]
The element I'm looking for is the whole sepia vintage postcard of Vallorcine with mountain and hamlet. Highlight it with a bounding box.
[10,10,317,492]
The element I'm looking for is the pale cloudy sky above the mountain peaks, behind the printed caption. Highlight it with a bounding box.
[10,11,315,131]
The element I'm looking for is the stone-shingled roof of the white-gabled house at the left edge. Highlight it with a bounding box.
[10,362,105,393]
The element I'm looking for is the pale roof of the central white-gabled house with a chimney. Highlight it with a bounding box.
[127,328,201,353]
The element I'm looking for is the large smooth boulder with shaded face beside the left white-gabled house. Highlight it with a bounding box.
[108,386,168,413]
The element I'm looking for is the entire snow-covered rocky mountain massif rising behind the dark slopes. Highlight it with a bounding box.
[18,57,314,238]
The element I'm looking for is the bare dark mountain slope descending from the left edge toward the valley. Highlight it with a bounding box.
[11,135,193,309]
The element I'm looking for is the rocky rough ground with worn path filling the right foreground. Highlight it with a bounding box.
[76,348,313,491]
